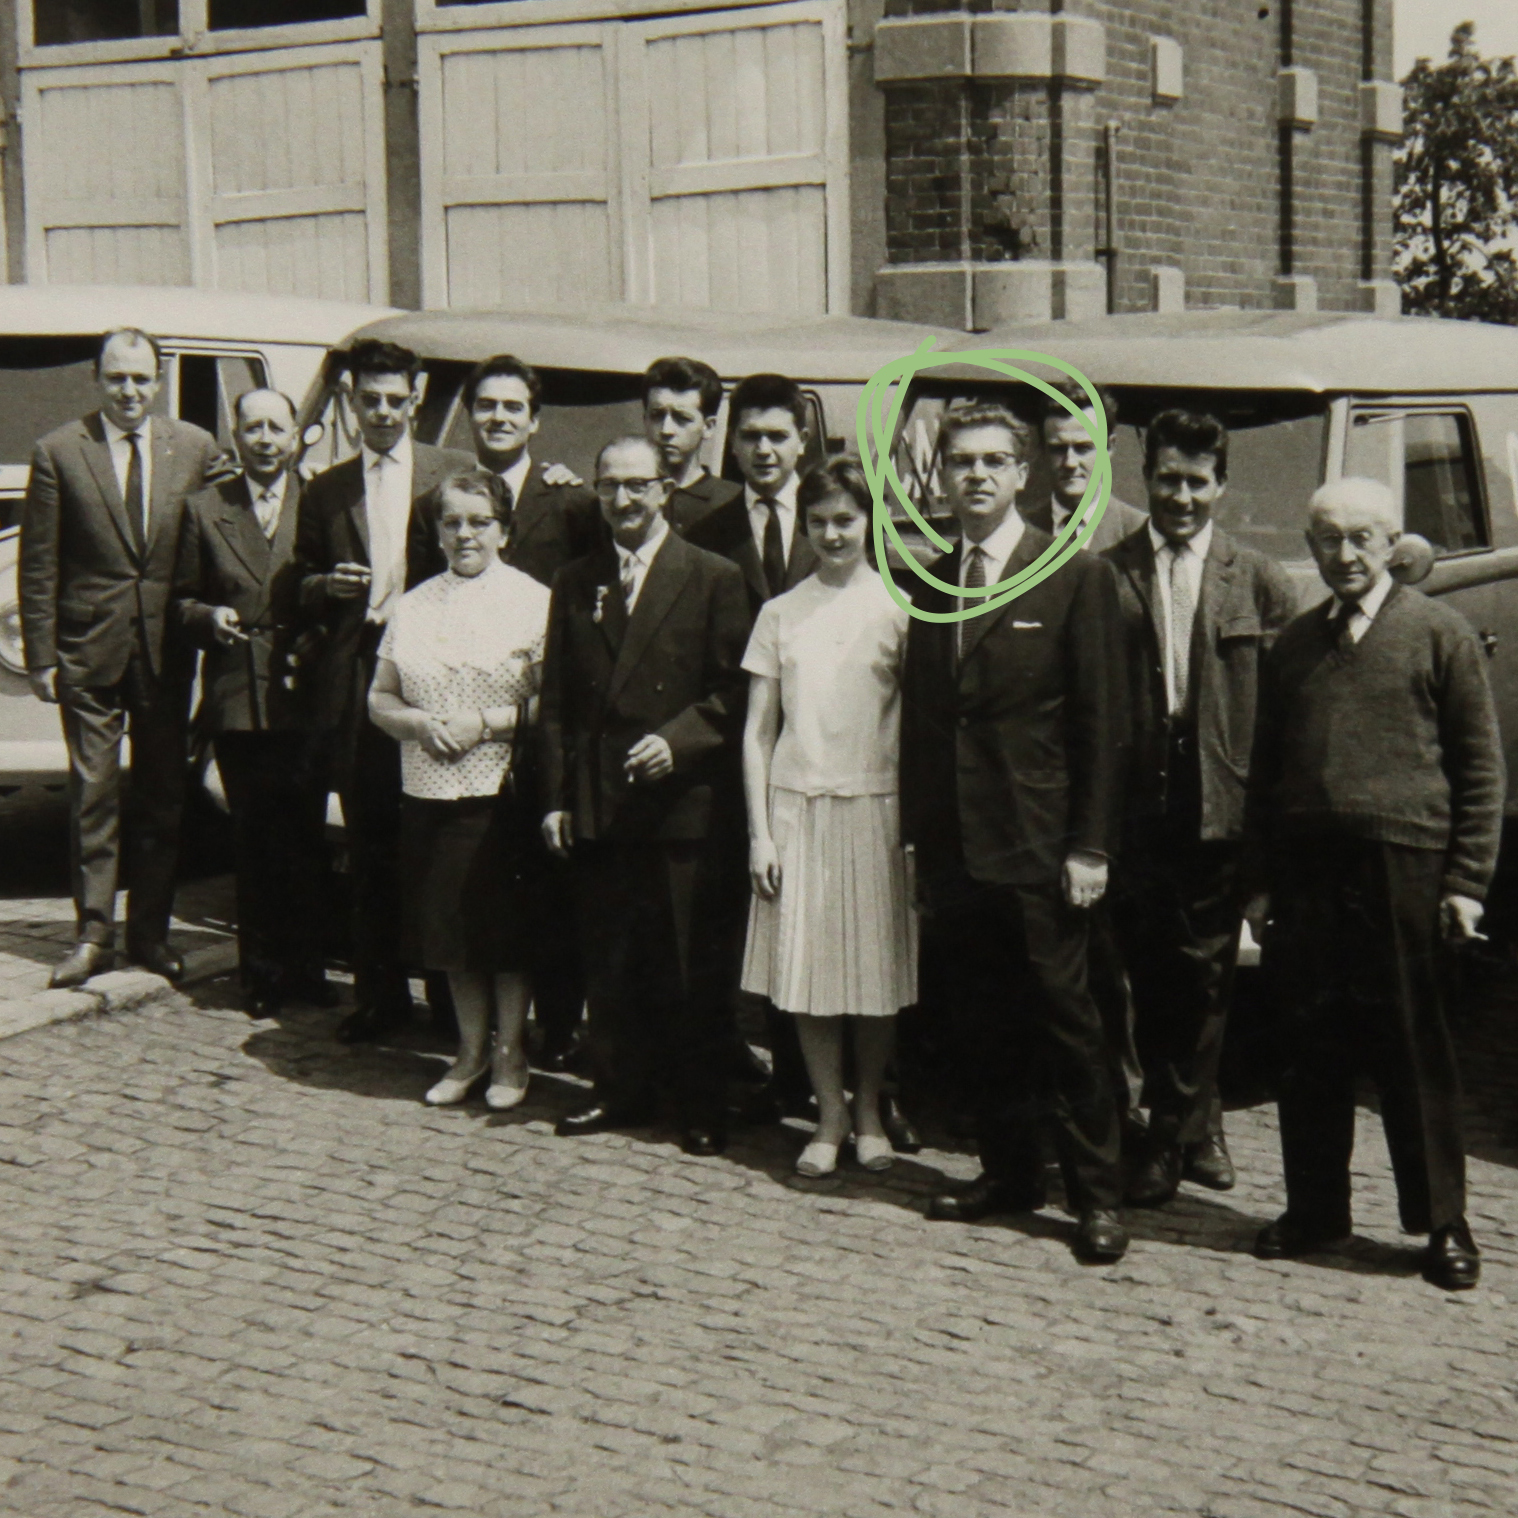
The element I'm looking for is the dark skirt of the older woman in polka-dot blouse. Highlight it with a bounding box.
[401,791,536,975]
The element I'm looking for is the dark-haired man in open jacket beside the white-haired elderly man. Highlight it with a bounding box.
[1107,411,1296,1207]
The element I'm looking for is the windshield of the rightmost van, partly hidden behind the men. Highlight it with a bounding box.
[894,383,1328,562]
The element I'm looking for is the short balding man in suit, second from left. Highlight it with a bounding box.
[175,390,335,1017]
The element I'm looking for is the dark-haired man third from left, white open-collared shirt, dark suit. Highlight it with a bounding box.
[296,339,474,1043]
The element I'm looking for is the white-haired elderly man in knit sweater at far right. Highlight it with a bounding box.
[1246,478,1504,1290]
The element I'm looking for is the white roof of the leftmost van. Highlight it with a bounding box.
[0,284,395,346]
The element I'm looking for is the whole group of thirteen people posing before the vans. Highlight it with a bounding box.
[21,331,1504,1289]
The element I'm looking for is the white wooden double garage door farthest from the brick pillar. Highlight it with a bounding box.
[21,43,389,301]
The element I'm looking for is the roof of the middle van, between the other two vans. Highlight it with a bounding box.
[340,305,964,381]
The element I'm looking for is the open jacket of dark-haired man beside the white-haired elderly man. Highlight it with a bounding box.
[1105,524,1296,839]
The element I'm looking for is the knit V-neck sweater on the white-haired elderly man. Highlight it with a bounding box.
[1248,586,1504,900]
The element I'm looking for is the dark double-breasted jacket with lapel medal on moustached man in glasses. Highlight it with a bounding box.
[540,531,750,841]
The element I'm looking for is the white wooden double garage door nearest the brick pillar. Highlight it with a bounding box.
[420,0,849,314]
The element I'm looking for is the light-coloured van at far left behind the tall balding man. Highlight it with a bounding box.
[0,285,397,817]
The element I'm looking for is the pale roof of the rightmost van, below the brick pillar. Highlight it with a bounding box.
[931,310,1518,395]
